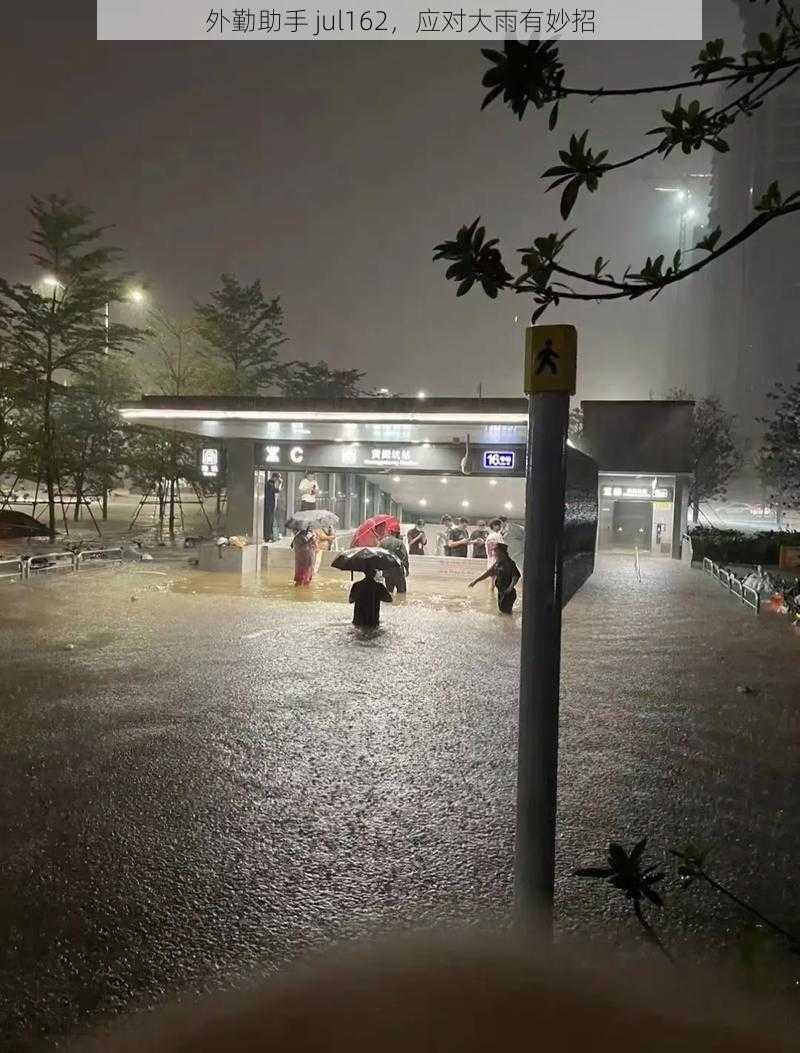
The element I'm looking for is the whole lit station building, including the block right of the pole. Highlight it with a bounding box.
[121,397,693,575]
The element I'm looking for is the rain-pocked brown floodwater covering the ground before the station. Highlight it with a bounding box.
[0,559,800,1050]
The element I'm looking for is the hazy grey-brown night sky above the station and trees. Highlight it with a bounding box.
[0,0,738,398]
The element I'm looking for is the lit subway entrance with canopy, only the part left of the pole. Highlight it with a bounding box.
[122,398,536,572]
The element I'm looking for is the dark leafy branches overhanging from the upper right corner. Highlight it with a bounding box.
[434,6,800,321]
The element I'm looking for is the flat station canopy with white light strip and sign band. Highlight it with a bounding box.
[121,396,527,515]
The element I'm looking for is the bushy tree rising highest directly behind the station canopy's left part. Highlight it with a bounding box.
[195,274,286,395]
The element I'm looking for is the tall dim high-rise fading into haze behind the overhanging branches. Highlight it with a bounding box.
[693,0,800,445]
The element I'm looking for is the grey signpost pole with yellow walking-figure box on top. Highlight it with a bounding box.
[514,326,576,937]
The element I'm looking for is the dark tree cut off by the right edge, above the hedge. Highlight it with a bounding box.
[757,365,800,530]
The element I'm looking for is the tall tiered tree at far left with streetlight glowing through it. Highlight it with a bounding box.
[0,195,139,537]
